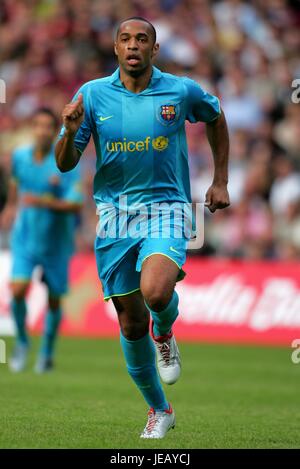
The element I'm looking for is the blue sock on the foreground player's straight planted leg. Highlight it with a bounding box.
[120,333,169,411]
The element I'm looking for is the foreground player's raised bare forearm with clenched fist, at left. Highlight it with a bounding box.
[55,94,84,172]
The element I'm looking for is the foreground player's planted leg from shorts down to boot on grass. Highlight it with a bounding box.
[95,237,175,438]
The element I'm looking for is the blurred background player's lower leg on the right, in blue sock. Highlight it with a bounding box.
[35,293,62,373]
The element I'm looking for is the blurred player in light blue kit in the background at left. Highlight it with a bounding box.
[3,108,82,373]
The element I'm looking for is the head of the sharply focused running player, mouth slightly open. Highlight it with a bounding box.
[115,20,159,76]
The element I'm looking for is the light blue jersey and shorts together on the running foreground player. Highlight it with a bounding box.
[60,67,221,300]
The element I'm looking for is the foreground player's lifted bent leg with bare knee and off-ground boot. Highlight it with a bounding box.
[141,254,181,384]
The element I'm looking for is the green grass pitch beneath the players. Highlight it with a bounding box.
[0,338,300,449]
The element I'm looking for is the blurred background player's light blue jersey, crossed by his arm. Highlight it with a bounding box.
[12,146,82,258]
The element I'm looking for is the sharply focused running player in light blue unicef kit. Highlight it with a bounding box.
[56,17,229,438]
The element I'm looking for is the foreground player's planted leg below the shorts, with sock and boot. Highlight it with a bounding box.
[112,291,175,438]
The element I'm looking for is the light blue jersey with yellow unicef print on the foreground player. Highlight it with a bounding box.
[59,67,220,209]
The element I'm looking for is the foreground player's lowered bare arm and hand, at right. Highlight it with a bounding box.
[205,111,230,213]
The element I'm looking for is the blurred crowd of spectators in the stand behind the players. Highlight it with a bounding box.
[0,0,300,259]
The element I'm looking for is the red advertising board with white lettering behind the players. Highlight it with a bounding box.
[0,250,300,345]
